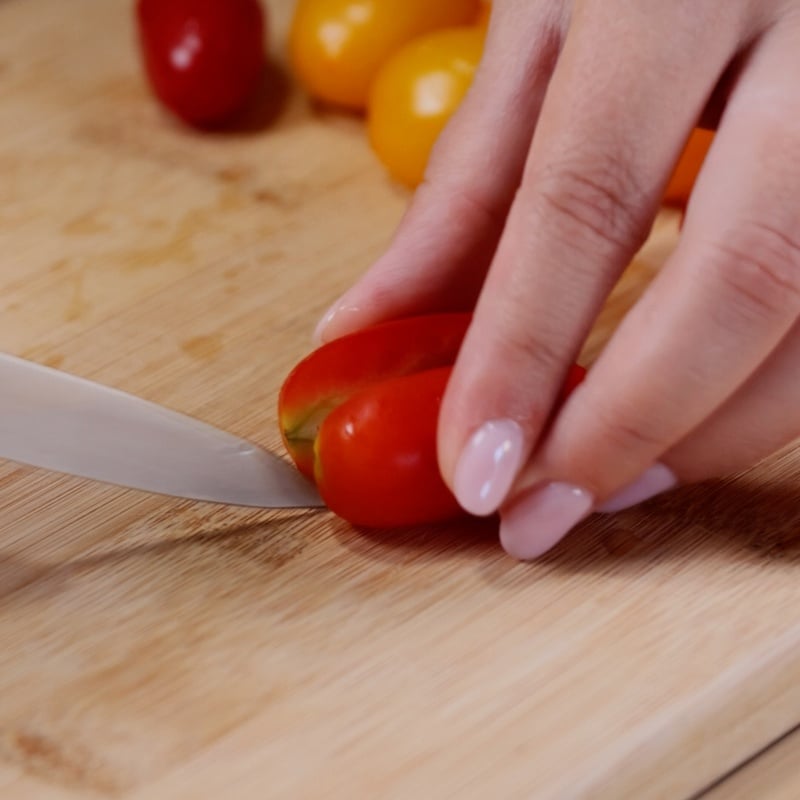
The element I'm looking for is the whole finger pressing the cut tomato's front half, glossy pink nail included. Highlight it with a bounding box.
[439,0,743,514]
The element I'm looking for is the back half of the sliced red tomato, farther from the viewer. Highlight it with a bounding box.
[278,312,472,478]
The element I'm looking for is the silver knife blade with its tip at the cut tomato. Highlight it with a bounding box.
[0,353,323,508]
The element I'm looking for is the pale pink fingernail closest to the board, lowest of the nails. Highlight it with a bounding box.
[500,483,594,561]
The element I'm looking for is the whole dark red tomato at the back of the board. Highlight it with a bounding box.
[137,0,266,127]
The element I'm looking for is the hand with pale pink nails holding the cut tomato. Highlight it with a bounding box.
[312,0,800,558]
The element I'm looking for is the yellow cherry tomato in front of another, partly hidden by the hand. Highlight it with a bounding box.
[367,25,486,187]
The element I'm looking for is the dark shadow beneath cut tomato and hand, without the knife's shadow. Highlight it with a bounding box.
[334,466,800,582]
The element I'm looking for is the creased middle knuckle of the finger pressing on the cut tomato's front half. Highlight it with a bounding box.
[533,156,650,255]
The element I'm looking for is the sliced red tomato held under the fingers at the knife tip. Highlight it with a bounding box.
[278,313,586,527]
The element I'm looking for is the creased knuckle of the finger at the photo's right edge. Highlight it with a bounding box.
[714,222,800,322]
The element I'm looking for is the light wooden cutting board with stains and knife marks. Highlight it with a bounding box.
[0,0,800,800]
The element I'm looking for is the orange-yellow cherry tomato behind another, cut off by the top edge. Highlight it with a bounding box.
[289,0,480,110]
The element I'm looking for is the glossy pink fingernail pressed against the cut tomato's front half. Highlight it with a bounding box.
[453,419,523,516]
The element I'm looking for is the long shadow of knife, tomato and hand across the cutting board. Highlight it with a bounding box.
[0,453,800,602]
